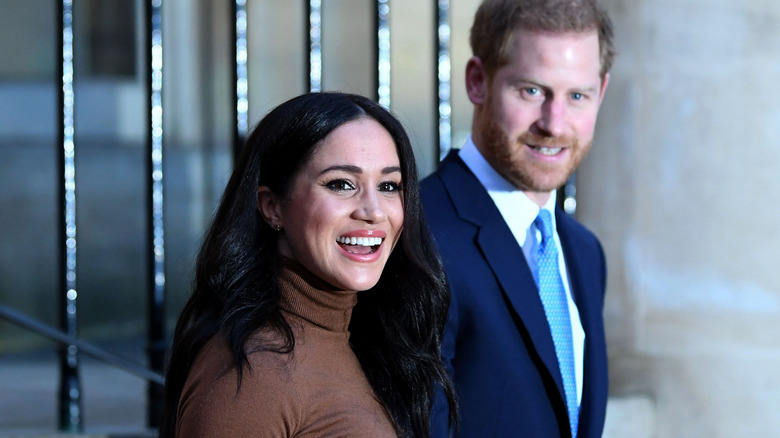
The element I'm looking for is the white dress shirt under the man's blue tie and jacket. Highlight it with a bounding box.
[459,136,585,403]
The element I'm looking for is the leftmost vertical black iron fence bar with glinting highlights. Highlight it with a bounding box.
[58,0,83,432]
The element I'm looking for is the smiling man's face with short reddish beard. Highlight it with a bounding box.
[467,30,608,204]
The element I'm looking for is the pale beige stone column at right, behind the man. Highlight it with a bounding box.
[578,0,780,437]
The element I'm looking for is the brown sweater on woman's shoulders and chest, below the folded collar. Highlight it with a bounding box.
[177,321,395,438]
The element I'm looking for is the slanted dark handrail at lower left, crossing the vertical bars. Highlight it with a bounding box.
[0,305,165,385]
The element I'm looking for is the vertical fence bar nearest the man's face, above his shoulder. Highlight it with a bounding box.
[436,0,452,161]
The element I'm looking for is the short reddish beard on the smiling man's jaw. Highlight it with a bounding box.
[480,104,591,193]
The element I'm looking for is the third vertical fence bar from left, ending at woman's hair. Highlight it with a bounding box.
[231,0,249,160]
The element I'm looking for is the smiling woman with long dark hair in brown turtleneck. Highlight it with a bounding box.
[161,93,456,437]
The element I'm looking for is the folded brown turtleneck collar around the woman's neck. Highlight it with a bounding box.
[279,258,357,332]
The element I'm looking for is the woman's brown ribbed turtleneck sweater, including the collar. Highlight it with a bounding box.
[176,261,397,438]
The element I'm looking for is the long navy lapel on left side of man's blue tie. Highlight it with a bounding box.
[439,151,565,400]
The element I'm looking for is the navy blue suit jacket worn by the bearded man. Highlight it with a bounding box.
[422,151,608,438]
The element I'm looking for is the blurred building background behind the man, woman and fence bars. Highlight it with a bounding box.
[0,0,780,438]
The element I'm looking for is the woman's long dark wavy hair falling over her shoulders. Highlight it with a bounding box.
[160,93,457,437]
